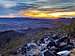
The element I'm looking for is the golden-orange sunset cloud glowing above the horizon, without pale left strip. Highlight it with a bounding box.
[21,10,75,19]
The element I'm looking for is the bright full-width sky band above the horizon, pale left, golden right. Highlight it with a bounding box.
[0,10,75,19]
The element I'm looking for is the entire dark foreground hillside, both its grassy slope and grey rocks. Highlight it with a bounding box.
[0,28,75,56]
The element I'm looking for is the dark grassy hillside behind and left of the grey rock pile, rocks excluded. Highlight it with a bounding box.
[0,28,75,56]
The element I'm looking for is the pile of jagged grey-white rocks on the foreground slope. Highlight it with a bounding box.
[16,32,75,56]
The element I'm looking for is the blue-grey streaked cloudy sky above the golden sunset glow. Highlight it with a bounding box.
[0,0,75,16]
